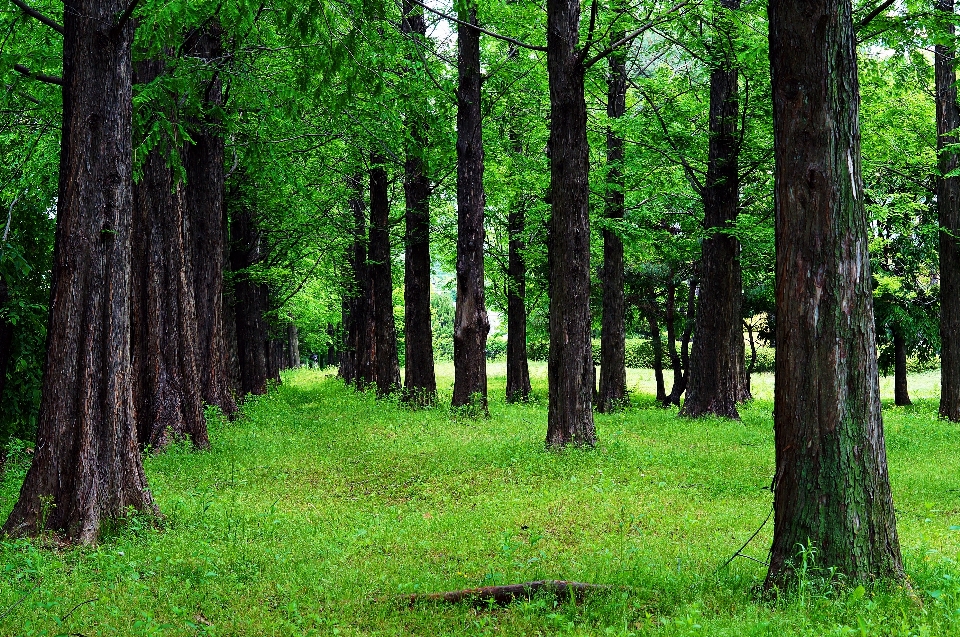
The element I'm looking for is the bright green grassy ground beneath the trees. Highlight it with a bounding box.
[0,364,960,637]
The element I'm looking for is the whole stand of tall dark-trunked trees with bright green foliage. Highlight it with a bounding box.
[0,0,960,586]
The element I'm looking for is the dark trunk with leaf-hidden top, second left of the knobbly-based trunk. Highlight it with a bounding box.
[367,153,400,396]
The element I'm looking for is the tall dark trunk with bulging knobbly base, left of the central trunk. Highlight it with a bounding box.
[453,5,490,410]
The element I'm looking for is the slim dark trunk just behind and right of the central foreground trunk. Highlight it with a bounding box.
[597,16,627,413]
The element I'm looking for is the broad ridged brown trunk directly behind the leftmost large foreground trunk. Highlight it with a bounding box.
[130,61,210,449]
